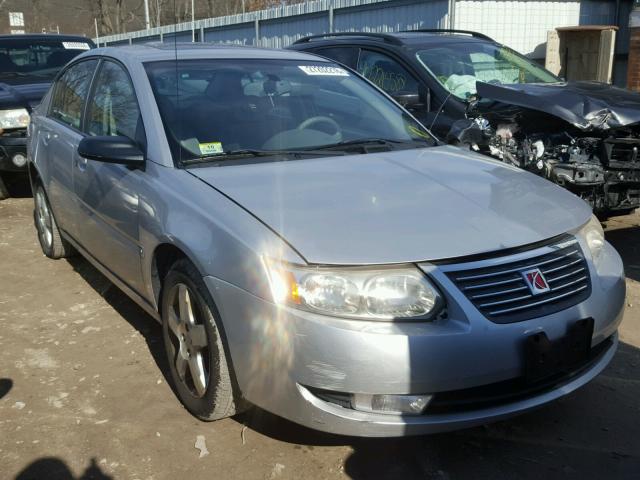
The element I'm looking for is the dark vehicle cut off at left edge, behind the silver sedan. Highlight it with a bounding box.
[0,34,95,200]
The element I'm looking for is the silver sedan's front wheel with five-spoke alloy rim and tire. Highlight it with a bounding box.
[161,259,238,421]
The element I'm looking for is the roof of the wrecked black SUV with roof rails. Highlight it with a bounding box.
[292,29,494,49]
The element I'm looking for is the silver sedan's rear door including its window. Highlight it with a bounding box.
[44,59,98,237]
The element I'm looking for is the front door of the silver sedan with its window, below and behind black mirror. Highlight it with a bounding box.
[72,60,146,292]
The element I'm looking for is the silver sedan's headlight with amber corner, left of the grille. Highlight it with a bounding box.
[265,260,444,320]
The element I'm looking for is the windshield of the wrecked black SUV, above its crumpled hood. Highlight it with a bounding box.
[416,42,560,100]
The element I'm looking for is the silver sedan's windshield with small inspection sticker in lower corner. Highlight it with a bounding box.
[145,59,434,161]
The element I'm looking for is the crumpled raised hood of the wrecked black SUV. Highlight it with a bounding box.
[476,82,640,131]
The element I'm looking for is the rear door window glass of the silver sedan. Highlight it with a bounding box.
[49,60,98,130]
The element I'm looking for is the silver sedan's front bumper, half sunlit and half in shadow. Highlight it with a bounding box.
[205,239,625,436]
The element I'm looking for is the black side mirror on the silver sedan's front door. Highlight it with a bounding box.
[78,136,144,168]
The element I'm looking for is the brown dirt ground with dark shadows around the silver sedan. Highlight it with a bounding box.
[0,192,640,480]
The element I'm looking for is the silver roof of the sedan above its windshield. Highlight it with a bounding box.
[78,42,331,63]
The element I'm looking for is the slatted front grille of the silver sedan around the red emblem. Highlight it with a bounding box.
[447,239,591,323]
